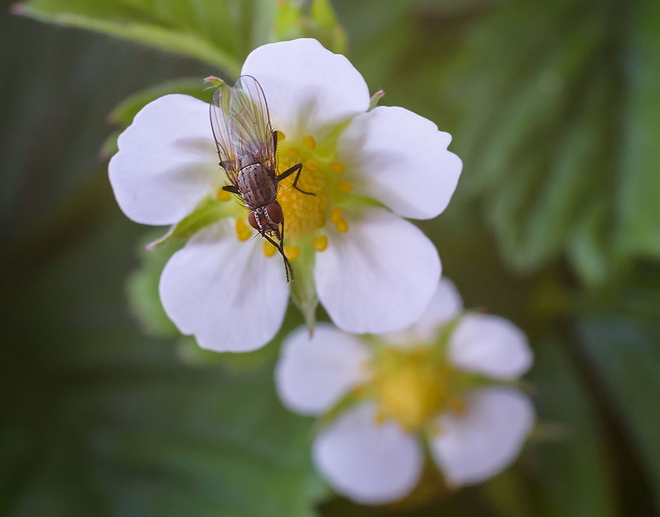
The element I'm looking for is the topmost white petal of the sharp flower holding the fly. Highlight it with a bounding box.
[241,39,369,139]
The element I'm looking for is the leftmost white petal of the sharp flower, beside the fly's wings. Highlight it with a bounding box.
[108,95,222,225]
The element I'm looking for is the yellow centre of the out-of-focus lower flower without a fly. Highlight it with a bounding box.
[370,346,461,432]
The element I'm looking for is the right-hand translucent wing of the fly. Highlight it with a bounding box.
[228,75,275,169]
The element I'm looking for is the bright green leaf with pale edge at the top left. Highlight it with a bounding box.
[18,0,274,77]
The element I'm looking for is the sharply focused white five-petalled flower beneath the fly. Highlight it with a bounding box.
[109,39,461,351]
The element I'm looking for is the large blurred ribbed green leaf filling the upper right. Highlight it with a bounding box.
[366,0,660,285]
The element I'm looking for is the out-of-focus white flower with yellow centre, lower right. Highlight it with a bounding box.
[276,279,535,504]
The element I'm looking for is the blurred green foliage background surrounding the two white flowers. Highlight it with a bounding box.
[0,0,660,517]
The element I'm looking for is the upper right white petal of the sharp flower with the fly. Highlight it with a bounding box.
[337,106,463,219]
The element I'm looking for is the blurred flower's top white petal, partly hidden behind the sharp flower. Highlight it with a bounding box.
[383,277,463,347]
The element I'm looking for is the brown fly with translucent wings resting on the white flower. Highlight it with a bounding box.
[210,75,314,281]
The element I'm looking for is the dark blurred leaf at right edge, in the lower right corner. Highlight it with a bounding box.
[578,314,660,507]
